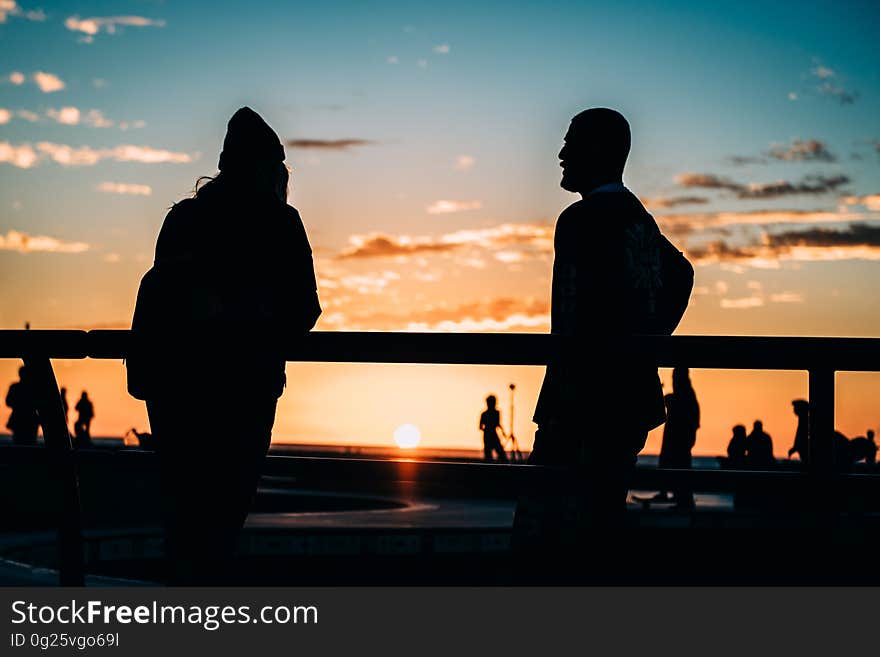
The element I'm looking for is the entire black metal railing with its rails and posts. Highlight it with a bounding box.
[0,330,880,585]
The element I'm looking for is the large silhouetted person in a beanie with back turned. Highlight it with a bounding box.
[128,107,321,584]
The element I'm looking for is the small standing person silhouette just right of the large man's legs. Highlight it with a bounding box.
[655,367,700,508]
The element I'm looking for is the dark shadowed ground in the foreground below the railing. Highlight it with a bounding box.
[0,448,880,586]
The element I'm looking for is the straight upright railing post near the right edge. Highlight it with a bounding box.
[808,366,836,524]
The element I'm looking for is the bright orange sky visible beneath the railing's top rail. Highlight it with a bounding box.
[0,348,880,457]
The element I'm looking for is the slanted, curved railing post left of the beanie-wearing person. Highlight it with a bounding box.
[24,353,85,586]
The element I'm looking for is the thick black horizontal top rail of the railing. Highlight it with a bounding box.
[0,329,880,372]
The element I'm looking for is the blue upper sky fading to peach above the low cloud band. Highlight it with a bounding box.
[0,2,880,324]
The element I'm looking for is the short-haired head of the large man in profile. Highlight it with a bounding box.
[559,107,631,193]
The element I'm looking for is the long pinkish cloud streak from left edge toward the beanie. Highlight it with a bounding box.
[0,141,195,169]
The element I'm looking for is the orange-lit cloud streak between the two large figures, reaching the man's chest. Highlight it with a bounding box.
[337,223,553,259]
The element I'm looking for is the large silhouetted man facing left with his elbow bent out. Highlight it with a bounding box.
[514,108,693,565]
